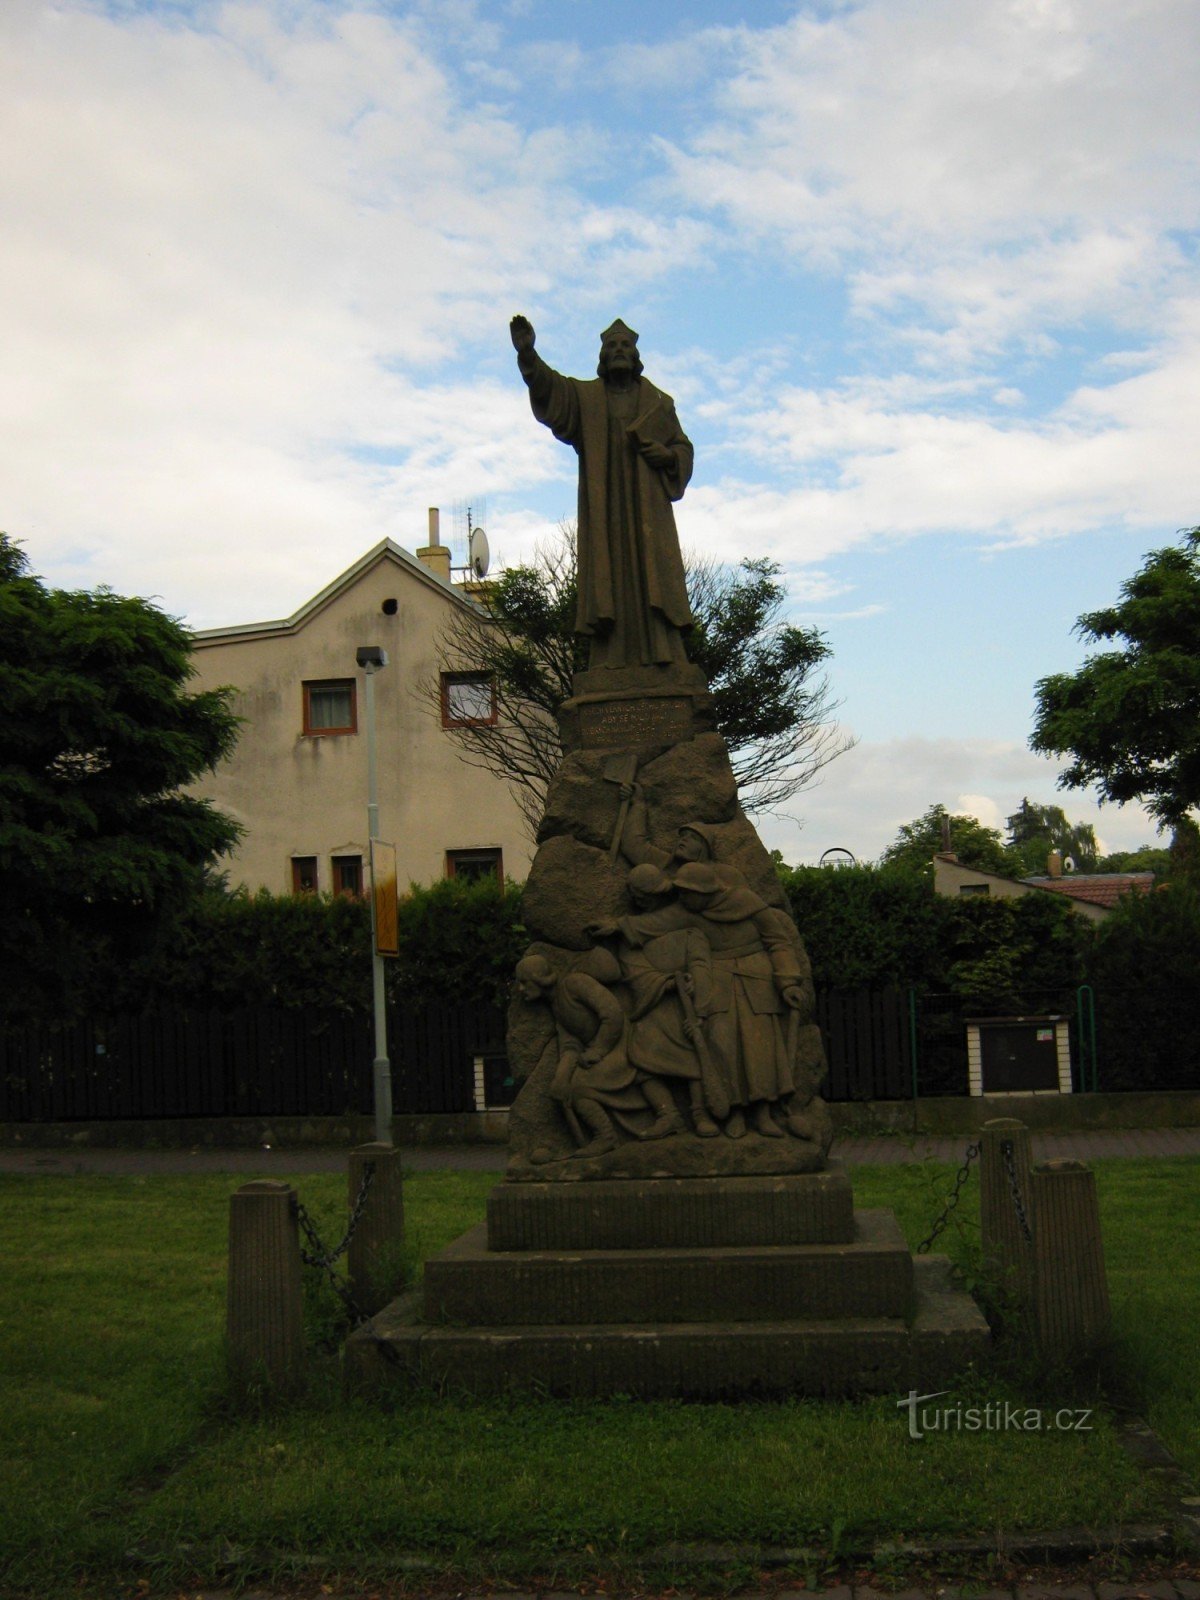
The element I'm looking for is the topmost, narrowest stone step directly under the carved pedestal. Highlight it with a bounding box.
[488,1162,854,1250]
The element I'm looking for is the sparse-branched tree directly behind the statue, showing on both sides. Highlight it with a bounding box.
[421,526,853,829]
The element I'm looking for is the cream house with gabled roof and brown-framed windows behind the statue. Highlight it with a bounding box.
[192,531,533,894]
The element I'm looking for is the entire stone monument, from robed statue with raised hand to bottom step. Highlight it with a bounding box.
[347,317,987,1397]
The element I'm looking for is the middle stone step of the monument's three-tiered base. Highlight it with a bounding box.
[424,1211,912,1326]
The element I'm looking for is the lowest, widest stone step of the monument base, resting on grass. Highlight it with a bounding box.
[346,1256,989,1395]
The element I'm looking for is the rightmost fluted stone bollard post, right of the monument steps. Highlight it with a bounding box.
[1034,1160,1109,1362]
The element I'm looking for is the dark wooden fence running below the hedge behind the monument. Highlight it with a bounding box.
[0,989,912,1123]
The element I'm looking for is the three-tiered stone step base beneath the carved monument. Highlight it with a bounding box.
[346,1166,989,1398]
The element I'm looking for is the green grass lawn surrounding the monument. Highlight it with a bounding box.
[0,1158,1200,1595]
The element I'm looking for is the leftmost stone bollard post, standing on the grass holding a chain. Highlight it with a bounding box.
[226,1178,304,1389]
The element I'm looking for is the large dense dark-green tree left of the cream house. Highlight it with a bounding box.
[0,534,238,1010]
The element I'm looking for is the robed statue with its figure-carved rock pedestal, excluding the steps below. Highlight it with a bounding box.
[509,317,830,1181]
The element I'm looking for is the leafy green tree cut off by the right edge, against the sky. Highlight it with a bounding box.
[1029,528,1200,824]
